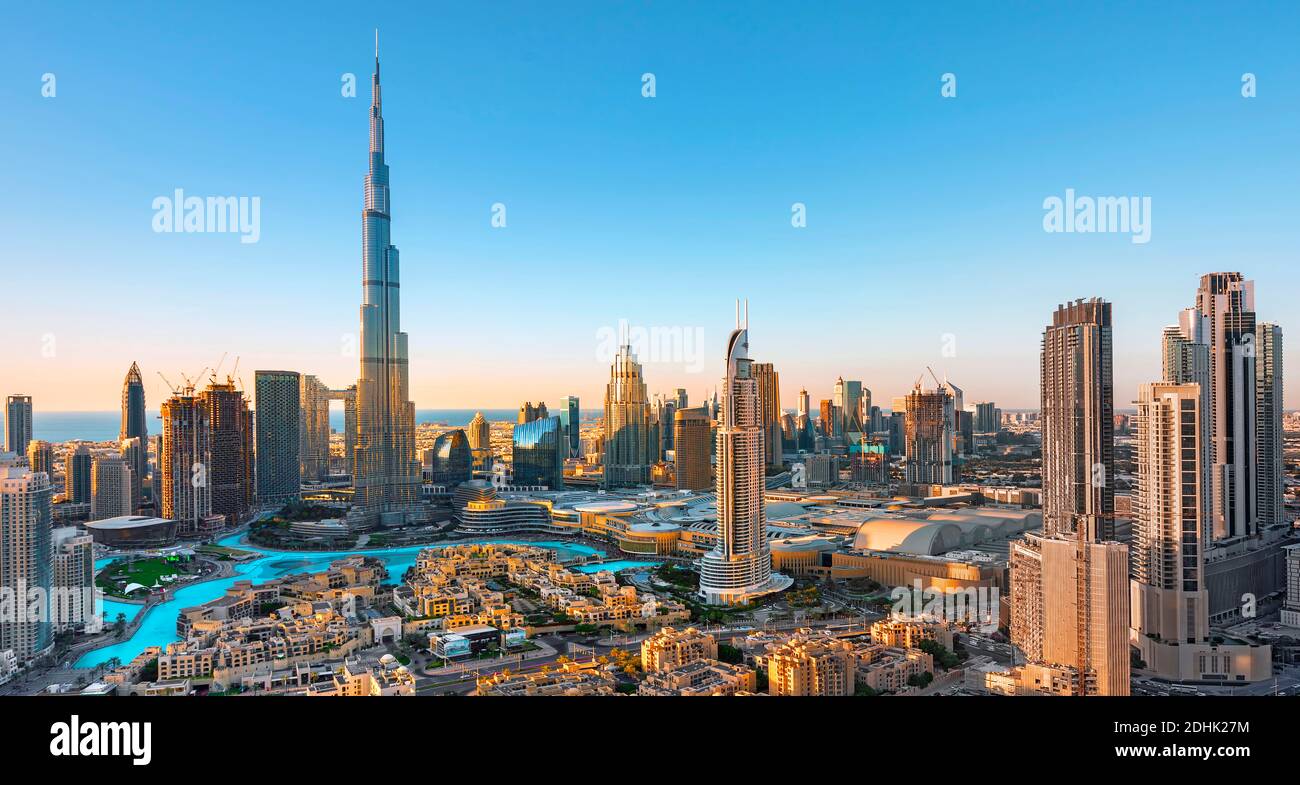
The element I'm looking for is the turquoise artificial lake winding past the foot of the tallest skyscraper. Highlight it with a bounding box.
[75,534,639,668]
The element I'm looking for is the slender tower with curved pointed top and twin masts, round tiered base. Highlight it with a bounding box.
[699,308,793,604]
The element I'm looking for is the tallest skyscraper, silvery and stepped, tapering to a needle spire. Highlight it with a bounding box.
[351,38,420,522]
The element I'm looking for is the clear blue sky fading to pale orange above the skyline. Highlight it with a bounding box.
[0,1,1300,409]
